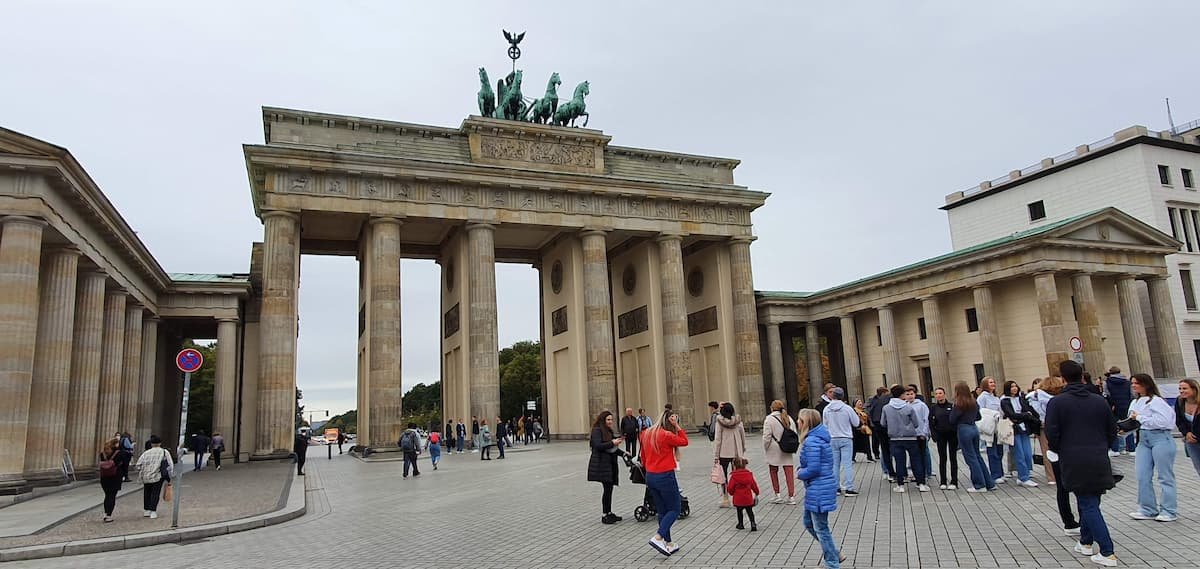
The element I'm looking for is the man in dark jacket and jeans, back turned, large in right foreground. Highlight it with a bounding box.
[1045,360,1117,565]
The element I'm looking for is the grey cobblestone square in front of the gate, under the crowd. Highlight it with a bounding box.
[11,436,1200,569]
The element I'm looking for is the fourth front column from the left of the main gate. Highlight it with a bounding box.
[580,229,617,417]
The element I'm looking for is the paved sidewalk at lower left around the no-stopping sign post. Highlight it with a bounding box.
[0,456,290,549]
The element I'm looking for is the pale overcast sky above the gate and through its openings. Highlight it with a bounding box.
[0,0,1200,413]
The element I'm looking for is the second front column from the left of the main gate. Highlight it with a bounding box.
[366,217,403,450]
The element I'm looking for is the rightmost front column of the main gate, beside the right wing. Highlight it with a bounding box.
[730,238,767,425]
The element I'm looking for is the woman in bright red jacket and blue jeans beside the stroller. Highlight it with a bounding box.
[640,408,688,556]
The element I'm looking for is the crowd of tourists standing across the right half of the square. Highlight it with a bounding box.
[587,361,1200,568]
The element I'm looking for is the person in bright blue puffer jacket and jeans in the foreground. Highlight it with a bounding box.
[796,409,845,569]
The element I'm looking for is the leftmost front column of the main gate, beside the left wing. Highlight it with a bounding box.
[251,211,300,460]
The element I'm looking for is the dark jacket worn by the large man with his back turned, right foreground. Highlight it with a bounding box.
[1045,383,1117,496]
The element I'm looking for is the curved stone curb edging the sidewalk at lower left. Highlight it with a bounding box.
[0,474,308,563]
